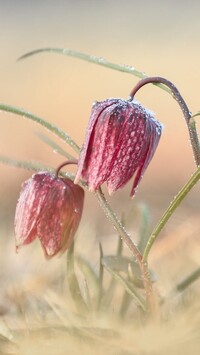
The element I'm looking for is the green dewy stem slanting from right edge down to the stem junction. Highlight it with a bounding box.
[143,167,200,262]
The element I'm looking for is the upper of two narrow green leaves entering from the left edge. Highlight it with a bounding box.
[0,104,80,153]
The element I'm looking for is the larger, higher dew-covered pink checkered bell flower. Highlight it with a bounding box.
[75,99,162,197]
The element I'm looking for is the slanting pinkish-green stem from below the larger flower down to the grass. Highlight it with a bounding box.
[96,188,155,314]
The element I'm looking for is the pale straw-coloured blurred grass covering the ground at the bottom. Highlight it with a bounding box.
[0,216,200,355]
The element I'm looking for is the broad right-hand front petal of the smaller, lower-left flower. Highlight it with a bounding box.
[37,178,84,257]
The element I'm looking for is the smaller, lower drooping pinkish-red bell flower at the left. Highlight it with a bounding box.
[15,172,84,257]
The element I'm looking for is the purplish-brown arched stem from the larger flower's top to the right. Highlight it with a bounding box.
[130,76,200,166]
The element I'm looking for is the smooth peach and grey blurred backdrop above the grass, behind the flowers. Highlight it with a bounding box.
[0,0,200,243]
